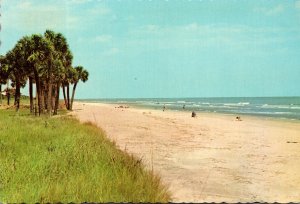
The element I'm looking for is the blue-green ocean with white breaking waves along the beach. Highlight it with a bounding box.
[78,97,300,120]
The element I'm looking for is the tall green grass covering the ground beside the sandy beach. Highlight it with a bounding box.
[0,110,170,203]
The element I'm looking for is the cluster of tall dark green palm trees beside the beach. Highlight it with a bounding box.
[0,30,89,115]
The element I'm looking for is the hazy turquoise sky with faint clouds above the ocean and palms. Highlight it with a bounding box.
[0,0,300,99]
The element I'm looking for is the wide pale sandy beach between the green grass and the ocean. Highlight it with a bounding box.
[73,103,300,202]
